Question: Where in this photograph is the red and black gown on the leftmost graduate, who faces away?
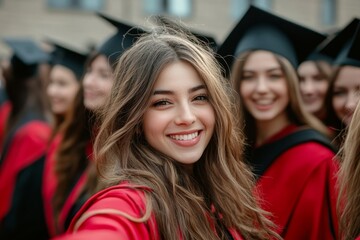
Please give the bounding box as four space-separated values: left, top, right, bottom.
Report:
0 120 51 239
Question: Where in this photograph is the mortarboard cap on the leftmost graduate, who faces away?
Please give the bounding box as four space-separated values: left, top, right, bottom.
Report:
4 38 49 79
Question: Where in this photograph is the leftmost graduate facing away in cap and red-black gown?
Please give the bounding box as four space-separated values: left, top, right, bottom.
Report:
0 39 51 239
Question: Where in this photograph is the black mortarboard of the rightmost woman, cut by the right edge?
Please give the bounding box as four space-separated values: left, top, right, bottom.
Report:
320 18 360 67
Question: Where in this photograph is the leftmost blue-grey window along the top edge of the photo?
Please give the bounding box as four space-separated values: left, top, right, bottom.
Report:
47 0 104 11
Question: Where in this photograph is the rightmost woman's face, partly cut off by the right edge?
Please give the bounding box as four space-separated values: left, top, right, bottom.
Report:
332 66 360 125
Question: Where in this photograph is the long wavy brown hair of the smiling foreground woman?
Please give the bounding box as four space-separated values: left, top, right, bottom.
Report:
94 27 278 240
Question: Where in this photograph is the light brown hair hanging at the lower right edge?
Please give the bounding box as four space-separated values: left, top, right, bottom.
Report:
337 101 360 240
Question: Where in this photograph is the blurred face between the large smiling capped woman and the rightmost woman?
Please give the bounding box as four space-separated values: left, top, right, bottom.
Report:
298 61 329 114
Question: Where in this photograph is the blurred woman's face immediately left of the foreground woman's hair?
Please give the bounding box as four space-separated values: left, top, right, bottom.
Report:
83 55 114 110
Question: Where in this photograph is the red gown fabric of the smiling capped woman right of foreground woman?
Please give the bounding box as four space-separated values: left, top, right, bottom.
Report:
256 126 338 240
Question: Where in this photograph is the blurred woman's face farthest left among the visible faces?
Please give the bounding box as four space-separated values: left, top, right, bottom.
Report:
46 65 80 115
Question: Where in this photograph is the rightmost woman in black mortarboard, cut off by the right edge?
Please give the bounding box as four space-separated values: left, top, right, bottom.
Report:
320 18 360 146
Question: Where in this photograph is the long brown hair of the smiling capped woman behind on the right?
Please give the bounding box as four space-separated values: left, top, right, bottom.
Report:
231 50 330 145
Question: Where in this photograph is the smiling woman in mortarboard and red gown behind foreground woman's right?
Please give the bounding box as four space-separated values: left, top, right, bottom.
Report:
218 6 337 240
